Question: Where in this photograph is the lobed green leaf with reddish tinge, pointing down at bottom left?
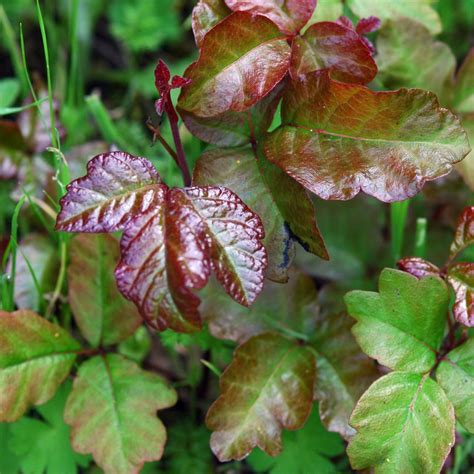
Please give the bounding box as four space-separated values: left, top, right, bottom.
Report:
64 354 176 474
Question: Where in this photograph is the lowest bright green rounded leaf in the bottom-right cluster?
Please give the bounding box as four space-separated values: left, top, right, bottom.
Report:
348 372 455 474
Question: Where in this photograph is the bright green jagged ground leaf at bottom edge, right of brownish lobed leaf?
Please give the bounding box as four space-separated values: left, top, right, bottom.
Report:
246 406 344 474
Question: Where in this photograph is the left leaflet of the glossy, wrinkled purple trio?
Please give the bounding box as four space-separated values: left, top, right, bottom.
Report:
56 151 160 232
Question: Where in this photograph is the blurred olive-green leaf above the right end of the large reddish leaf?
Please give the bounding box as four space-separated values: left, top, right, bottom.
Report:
376 18 456 103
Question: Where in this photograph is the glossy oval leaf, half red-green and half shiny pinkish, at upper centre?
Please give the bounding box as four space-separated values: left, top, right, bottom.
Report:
179 12 290 117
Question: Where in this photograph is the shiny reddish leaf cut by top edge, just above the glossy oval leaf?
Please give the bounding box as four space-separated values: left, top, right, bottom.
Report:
225 0 316 35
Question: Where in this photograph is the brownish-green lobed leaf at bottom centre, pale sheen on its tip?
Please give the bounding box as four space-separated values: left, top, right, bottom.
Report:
206 333 315 461
